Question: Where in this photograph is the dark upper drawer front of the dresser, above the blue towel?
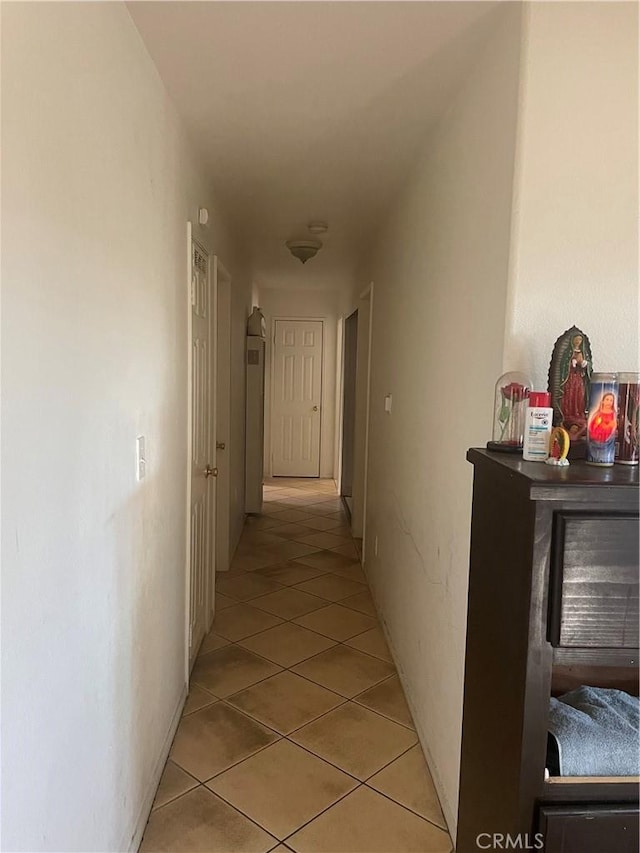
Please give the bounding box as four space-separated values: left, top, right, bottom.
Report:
548 513 639 649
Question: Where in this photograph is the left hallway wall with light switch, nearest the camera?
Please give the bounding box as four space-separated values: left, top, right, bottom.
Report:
1 3 248 851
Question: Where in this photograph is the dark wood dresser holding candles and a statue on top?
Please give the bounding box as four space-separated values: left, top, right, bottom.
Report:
456 450 639 853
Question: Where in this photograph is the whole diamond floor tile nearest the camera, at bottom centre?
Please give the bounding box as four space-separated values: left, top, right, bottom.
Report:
209 741 357 840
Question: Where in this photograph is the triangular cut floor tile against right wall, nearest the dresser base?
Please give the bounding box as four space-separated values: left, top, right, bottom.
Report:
367 744 447 829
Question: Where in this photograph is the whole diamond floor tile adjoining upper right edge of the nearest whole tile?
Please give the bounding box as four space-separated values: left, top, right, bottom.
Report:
288 700 417 781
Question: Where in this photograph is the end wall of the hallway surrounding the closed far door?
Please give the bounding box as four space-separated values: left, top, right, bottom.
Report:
259 288 338 477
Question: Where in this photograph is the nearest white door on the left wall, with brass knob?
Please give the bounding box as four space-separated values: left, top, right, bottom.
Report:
189 233 217 664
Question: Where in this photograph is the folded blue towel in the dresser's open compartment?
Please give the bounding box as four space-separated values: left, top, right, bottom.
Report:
549 687 640 776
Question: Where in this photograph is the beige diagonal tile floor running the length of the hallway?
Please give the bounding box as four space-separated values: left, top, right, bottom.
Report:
141 479 452 853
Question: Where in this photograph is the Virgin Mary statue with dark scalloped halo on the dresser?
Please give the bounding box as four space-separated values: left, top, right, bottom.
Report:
549 326 593 444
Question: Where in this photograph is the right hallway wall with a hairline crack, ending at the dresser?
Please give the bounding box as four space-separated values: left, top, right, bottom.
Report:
363 4 520 831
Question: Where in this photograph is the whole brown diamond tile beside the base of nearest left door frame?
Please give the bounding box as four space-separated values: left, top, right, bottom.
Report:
191 645 280 698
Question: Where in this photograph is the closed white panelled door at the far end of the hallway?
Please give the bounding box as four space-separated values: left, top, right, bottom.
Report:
271 320 323 477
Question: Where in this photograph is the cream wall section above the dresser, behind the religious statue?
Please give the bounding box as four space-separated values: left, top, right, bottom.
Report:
504 3 639 388
